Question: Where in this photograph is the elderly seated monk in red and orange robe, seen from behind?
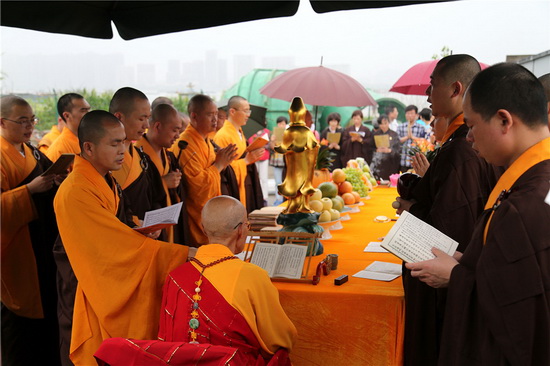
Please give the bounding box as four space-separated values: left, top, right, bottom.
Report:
95 196 297 366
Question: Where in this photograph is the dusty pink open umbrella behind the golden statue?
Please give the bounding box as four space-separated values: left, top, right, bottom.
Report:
260 66 376 107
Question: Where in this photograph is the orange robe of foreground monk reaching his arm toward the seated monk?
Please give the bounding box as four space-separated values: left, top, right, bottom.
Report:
54 156 188 366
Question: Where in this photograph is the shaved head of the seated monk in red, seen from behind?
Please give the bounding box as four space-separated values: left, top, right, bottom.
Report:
202 196 247 239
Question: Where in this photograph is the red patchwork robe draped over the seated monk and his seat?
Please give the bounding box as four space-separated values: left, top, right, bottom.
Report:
94 263 290 366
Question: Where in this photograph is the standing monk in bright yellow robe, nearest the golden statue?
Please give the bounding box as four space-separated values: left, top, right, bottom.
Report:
214 96 265 207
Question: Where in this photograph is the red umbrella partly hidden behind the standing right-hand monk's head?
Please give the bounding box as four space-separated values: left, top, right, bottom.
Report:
390 60 489 95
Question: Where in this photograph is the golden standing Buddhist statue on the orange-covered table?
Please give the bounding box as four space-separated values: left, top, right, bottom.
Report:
275 97 319 214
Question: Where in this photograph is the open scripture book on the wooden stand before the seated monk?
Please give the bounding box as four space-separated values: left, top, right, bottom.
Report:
250 243 307 279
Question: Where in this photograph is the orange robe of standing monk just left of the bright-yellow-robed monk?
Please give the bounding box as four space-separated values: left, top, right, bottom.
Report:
172 125 221 244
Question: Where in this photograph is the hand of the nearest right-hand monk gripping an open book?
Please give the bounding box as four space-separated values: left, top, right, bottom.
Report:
405 248 458 288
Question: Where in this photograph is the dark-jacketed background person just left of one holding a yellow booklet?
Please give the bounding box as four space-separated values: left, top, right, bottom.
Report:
342 109 372 166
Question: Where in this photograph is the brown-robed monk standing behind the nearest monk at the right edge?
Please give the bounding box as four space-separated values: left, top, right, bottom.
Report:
398 55 497 366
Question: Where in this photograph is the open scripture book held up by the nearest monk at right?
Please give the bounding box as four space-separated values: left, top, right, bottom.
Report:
380 211 458 263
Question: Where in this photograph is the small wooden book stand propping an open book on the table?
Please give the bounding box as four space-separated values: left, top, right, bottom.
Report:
244 231 320 283
